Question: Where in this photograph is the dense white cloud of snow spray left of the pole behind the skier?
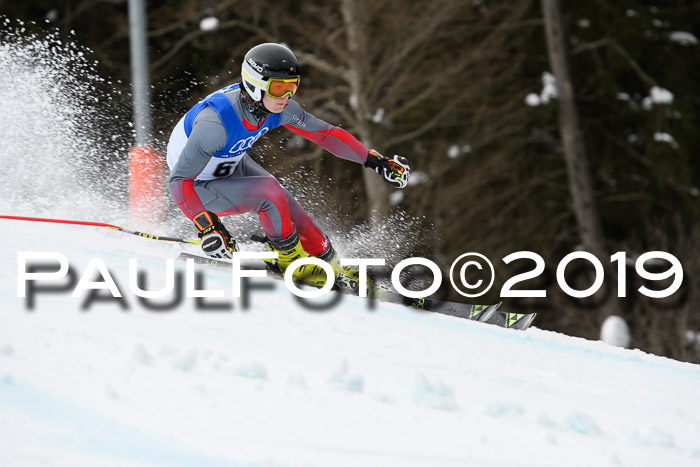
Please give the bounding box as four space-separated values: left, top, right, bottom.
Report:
0 17 131 221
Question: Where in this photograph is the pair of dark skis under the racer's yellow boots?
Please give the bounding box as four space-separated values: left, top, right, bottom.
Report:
177 253 537 330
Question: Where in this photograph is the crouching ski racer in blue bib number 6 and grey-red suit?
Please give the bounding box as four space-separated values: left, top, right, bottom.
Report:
167 43 410 286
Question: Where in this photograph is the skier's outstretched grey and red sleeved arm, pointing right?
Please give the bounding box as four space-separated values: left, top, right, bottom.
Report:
282 99 369 165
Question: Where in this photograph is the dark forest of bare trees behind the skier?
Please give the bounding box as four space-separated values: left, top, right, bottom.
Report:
0 0 700 362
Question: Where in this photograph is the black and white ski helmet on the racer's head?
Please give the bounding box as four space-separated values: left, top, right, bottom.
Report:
241 42 301 102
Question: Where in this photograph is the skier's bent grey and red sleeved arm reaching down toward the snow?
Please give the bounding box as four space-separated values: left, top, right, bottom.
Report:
168 109 226 219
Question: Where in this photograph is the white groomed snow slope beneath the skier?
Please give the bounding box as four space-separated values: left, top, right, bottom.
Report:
0 219 700 467
